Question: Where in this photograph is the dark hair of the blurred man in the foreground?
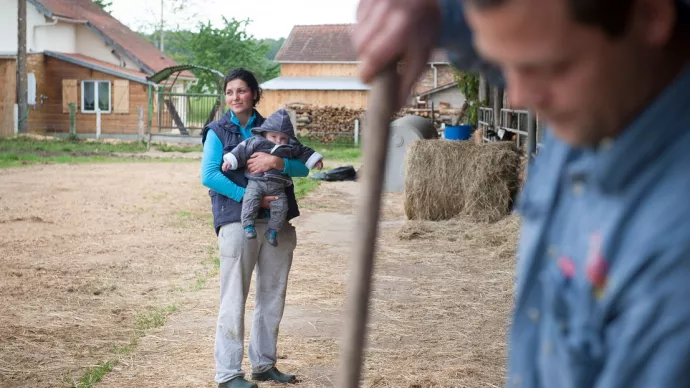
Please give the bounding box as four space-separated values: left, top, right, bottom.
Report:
465 0 676 38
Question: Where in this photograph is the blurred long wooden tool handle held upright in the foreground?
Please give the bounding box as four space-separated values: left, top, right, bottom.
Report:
338 63 399 388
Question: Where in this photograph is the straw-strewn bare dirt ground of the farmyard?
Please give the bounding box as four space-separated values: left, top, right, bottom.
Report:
0 162 517 388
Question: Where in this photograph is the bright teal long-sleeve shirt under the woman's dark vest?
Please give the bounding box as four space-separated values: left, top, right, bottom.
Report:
201 115 309 202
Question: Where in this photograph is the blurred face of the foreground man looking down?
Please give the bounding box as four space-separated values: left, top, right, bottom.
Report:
467 0 664 146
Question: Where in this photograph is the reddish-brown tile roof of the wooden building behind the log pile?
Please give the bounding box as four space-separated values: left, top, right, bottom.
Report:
275 24 448 63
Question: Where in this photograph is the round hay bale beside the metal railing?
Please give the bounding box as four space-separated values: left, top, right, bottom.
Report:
405 140 520 222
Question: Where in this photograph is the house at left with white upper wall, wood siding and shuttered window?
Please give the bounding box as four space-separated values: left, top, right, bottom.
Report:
0 0 195 135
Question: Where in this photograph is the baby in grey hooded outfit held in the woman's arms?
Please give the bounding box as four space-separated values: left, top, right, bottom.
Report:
222 109 323 247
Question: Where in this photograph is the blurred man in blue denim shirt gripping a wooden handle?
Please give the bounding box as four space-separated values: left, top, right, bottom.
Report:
354 0 690 388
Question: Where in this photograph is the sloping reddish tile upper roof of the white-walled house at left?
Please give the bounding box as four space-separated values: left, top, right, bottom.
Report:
31 0 193 77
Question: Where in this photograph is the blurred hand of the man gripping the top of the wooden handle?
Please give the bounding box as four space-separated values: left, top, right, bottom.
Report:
352 0 444 106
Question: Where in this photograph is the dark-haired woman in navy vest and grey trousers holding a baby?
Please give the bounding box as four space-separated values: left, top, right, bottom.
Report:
201 69 309 388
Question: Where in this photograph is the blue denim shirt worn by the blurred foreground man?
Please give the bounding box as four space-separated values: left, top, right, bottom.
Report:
440 0 690 388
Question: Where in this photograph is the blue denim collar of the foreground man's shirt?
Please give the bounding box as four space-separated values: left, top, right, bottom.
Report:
567 66 690 193
